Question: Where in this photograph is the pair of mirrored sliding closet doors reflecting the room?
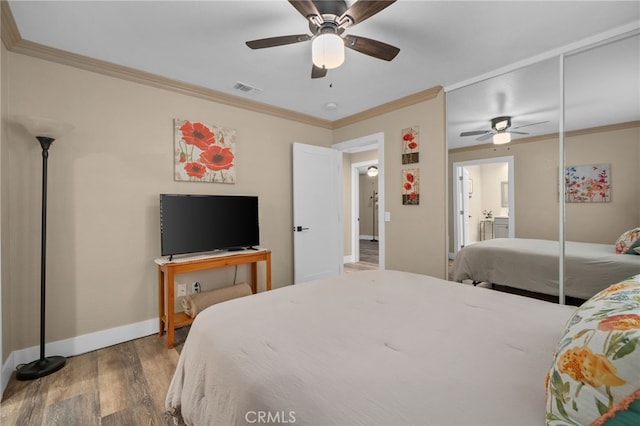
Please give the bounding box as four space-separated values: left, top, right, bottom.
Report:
447 35 640 304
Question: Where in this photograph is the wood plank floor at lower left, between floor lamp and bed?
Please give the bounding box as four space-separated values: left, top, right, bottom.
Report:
0 327 188 426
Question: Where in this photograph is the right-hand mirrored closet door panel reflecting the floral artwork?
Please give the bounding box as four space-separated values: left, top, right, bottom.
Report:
564 35 640 298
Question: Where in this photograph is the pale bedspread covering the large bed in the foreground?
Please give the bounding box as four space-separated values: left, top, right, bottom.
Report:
166 271 574 426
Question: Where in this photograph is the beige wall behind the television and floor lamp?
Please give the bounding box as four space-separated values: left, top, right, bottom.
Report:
0 52 332 359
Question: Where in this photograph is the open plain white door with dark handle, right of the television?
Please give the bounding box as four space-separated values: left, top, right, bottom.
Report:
293 143 343 284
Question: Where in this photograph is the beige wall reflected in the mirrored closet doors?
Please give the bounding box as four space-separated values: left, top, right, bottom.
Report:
448 125 640 247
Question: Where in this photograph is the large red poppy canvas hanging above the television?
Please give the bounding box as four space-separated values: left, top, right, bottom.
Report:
173 118 236 183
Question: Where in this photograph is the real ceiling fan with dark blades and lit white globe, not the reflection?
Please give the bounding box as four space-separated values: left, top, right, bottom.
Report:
246 0 400 78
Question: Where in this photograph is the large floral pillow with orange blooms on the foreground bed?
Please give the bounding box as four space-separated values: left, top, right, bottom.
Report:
546 275 640 426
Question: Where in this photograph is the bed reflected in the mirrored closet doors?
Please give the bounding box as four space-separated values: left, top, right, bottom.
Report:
453 238 640 300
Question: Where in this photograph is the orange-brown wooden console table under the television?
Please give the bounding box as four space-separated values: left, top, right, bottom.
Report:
155 249 271 349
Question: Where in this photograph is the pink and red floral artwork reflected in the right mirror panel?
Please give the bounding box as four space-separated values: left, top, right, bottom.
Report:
564 164 611 203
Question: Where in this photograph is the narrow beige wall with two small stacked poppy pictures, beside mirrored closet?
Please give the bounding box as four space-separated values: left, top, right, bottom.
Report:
334 91 446 278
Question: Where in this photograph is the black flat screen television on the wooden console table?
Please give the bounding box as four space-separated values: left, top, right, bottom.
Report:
160 194 260 256
